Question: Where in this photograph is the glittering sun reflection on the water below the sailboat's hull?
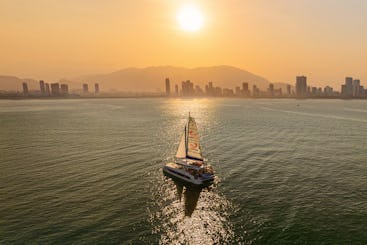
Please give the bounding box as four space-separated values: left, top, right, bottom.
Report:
151 179 234 244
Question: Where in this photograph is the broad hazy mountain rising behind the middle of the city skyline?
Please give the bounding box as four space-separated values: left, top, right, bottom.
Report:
74 66 269 91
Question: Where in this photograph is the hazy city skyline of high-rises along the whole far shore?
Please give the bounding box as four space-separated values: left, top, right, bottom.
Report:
7 75 367 99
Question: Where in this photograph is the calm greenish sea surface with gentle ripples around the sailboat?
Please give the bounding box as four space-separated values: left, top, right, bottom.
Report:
0 99 367 244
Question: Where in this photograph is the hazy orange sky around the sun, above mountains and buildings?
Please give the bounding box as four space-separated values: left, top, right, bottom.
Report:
0 0 367 85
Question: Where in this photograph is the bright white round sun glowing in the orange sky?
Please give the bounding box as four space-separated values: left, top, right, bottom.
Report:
177 5 204 32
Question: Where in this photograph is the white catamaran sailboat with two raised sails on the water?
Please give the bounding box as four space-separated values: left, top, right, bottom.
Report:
163 114 214 187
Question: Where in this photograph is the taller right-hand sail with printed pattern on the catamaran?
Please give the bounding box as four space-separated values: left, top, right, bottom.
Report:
187 117 203 160
